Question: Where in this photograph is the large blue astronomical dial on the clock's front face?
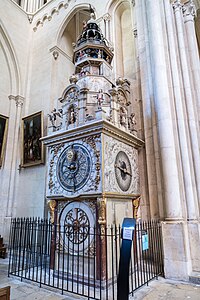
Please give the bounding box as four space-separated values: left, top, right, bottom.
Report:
57 143 91 192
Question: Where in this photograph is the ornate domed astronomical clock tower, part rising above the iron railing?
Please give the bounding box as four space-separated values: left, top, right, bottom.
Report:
43 14 143 240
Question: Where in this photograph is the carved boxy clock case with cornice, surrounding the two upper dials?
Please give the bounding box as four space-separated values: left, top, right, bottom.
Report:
43 120 143 224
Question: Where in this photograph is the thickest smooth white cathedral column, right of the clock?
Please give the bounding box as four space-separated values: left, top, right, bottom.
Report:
146 0 183 220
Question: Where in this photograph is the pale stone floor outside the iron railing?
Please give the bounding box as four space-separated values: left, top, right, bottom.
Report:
0 259 200 300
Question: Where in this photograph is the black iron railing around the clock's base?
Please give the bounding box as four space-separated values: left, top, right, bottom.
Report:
8 218 163 300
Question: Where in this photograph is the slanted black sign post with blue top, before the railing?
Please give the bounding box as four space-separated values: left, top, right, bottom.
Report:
117 218 136 300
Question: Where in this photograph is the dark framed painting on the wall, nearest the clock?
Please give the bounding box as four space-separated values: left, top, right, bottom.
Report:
22 111 44 167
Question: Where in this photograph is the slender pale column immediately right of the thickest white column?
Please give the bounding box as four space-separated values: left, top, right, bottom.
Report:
164 1 198 220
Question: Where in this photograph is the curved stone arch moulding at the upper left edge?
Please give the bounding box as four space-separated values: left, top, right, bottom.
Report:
0 21 21 95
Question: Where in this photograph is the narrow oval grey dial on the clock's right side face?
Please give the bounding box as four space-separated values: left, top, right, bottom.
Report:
115 151 132 192
